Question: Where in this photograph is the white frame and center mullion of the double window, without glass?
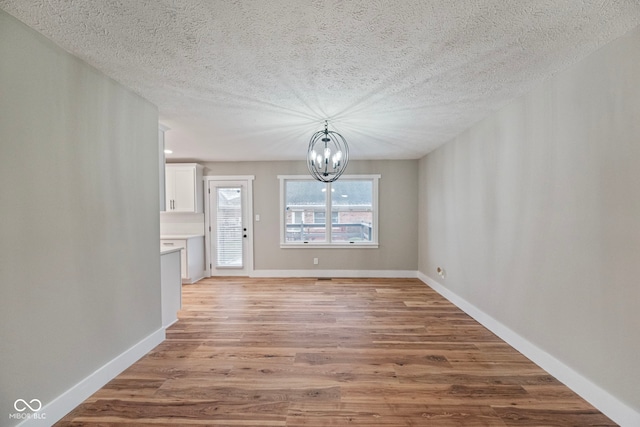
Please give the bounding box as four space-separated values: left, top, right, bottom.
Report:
278 175 381 249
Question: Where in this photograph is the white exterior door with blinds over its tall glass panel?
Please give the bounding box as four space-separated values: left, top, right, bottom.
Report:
207 179 252 276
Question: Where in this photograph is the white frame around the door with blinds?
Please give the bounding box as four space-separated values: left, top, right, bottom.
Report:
204 175 255 277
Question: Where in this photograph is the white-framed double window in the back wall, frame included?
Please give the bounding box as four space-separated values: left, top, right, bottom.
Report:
278 175 380 247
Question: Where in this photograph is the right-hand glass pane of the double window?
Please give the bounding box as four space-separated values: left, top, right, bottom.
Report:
331 180 373 242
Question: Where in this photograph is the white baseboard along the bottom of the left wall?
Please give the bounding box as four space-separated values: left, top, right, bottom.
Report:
18 328 165 427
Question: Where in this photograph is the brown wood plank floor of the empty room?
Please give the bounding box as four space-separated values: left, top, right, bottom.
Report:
57 278 615 427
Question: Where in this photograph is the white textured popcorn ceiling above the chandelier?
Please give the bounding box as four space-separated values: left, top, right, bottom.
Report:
0 0 640 161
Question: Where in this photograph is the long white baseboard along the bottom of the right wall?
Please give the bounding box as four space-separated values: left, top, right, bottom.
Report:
418 272 640 427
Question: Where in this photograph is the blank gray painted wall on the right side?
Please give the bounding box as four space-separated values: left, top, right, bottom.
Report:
419 29 640 411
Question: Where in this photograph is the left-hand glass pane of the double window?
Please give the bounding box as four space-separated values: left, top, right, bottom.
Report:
285 181 327 243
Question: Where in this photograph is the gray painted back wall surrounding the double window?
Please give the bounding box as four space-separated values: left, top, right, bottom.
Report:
204 160 418 271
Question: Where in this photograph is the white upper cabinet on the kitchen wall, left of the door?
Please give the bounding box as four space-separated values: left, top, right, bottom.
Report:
165 163 204 213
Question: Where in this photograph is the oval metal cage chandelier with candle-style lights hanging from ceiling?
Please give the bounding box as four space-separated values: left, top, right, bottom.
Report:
307 120 349 182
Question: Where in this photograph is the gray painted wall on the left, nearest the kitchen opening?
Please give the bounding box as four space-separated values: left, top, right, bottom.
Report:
0 11 161 425
